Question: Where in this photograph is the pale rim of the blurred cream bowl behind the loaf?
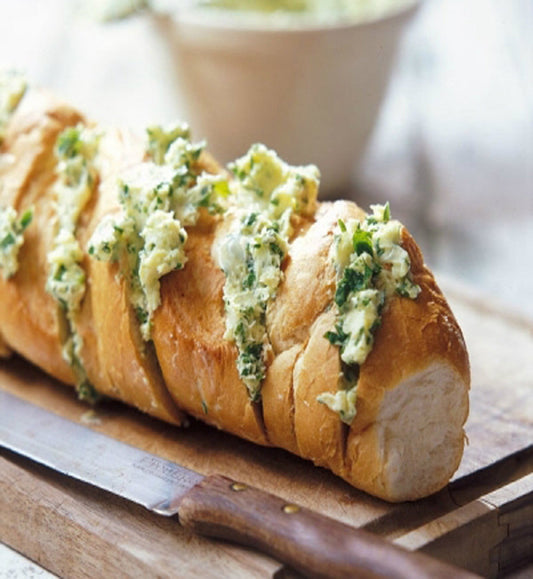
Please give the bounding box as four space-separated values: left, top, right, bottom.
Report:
171 0 424 34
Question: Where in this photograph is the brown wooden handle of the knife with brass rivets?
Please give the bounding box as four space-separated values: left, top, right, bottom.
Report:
179 476 476 579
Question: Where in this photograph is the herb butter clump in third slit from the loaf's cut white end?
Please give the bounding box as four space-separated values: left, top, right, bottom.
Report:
89 124 228 341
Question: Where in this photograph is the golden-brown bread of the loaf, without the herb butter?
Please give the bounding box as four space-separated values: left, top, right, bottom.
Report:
0 88 470 501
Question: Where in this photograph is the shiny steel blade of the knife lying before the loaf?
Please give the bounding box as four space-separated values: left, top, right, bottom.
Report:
0 391 204 516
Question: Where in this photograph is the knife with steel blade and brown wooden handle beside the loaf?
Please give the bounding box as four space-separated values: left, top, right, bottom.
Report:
0 390 475 579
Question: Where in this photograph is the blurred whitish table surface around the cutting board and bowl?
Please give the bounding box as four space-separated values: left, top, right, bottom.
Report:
0 0 533 578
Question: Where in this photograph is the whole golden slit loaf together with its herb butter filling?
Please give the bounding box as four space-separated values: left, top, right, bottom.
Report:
0 78 470 501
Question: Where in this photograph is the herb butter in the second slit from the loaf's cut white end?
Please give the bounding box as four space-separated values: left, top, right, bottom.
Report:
215 145 319 401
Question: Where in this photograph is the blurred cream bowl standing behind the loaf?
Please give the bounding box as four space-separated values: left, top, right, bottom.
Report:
156 2 418 197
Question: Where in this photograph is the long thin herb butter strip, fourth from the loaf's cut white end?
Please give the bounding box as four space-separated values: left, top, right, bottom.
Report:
46 125 100 401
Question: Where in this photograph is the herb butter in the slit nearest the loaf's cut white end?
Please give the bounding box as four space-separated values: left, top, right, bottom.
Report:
318 204 420 424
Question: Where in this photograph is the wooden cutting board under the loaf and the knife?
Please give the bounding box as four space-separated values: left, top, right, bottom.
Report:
0 280 533 577
